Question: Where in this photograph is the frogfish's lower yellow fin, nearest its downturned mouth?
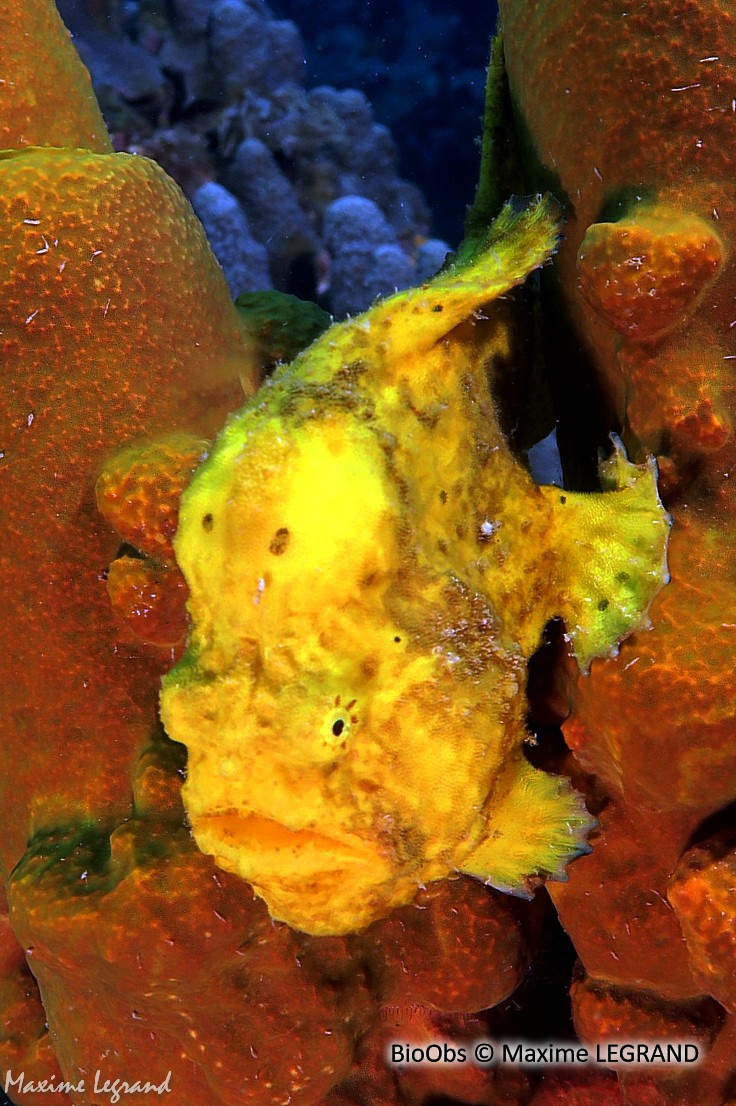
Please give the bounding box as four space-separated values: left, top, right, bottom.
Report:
460 758 595 898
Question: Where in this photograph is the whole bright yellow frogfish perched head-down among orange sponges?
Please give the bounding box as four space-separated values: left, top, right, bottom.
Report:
162 202 668 935
